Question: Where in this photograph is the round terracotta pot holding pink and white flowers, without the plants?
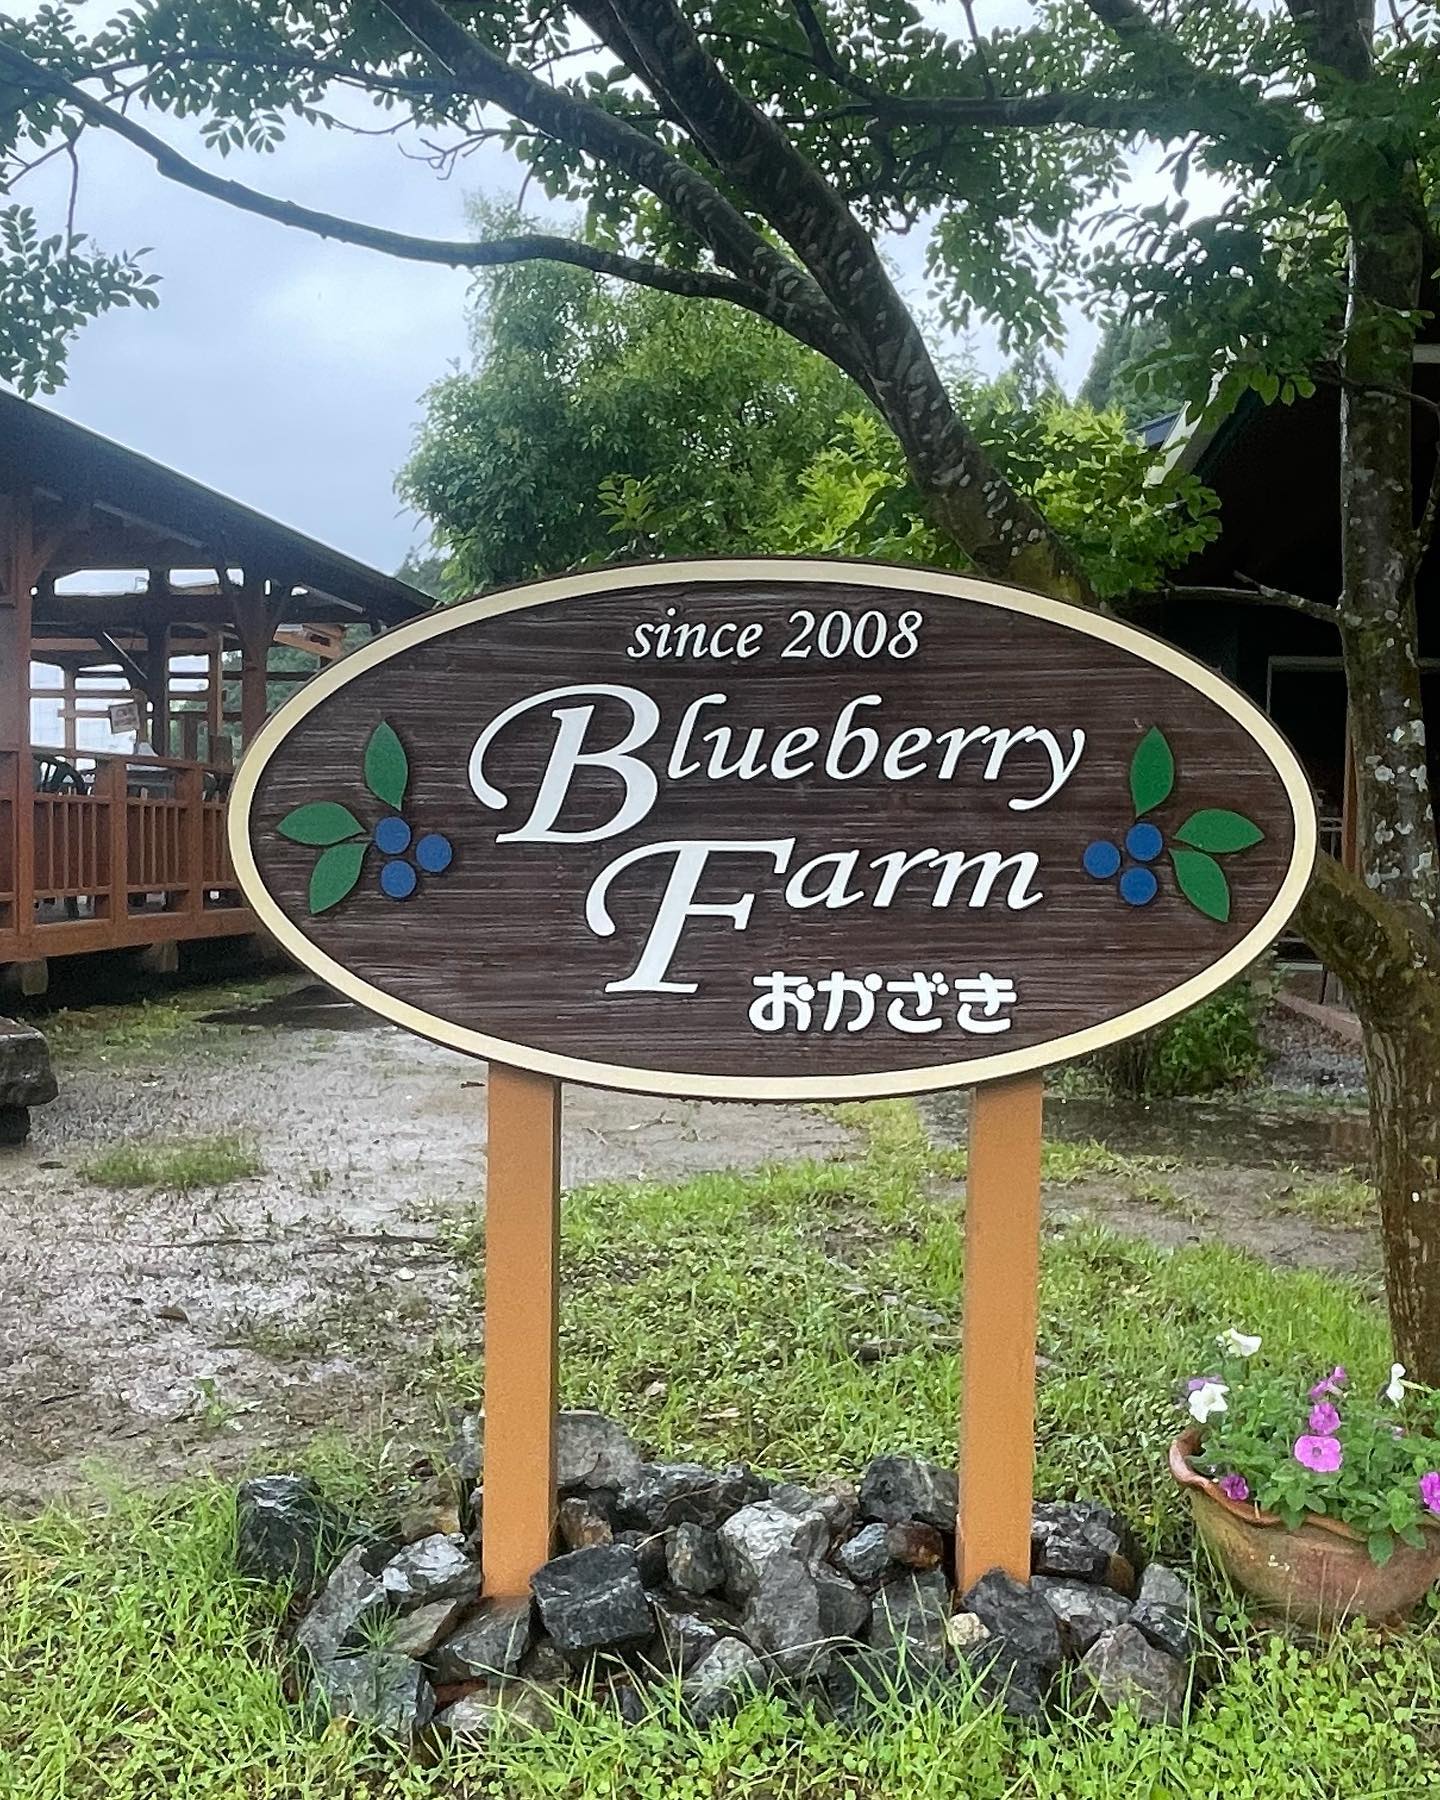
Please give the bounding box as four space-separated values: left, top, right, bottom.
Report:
1170 1429 1440 1627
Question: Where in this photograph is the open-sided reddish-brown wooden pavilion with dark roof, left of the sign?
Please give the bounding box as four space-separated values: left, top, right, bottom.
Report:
0 394 430 992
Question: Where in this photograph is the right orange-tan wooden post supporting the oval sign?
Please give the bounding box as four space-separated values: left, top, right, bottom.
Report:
956 1075 1044 1593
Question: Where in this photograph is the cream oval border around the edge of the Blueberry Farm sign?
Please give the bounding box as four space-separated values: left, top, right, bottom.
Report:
229 558 1316 1100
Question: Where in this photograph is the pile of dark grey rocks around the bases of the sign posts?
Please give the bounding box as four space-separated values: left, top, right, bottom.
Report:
238 1413 1199 1737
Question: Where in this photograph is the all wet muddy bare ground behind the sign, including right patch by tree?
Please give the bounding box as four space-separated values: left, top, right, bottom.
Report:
0 977 1375 1505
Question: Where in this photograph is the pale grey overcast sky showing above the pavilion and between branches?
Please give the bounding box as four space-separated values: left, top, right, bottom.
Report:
0 0 1093 569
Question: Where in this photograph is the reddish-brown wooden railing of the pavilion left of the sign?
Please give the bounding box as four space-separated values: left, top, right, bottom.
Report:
0 751 256 963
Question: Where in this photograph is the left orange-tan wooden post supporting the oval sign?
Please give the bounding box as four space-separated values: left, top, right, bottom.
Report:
482 1062 560 1598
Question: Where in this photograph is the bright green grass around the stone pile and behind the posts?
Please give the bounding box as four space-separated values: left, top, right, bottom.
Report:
0 1103 1440 1800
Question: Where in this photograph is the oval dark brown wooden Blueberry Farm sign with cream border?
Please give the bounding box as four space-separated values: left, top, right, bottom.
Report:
230 560 1316 1100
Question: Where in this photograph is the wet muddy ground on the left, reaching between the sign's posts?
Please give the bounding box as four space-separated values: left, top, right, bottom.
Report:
0 988 848 1503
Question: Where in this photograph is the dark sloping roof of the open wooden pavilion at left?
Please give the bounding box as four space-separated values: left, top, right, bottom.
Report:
0 392 432 625
